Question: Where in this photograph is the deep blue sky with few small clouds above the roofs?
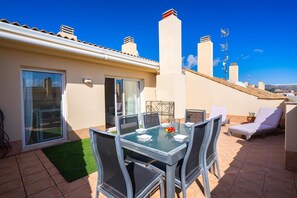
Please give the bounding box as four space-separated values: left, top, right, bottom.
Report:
0 0 297 84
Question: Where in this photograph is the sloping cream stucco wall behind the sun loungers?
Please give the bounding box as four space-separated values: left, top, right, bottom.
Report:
186 71 285 116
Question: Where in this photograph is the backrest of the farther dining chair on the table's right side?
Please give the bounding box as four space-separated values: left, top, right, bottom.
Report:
206 115 222 159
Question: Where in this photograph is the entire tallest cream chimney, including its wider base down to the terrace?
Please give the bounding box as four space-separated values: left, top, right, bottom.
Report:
156 9 186 119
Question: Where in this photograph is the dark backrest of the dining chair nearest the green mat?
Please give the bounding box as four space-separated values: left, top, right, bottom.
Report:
90 128 133 197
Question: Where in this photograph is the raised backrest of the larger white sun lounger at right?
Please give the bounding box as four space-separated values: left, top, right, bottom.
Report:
254 108 283 127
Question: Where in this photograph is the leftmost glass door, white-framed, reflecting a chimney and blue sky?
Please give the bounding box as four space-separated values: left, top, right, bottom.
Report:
22 70 64 146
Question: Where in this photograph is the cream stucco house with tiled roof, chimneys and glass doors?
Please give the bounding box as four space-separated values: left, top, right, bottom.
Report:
0 9 286 153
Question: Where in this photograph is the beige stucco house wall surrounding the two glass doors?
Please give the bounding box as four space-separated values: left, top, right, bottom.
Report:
0 47 156 141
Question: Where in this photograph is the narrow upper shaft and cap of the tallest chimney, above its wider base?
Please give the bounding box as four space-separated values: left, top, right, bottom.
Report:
159 9 182 74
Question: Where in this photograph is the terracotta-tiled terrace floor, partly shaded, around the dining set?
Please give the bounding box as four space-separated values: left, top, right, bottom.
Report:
0 128 297 198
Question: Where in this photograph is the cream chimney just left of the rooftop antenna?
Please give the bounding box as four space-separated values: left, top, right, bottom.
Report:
197 36 213 77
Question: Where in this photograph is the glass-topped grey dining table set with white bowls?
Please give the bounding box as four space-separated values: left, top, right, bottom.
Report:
121 123 191 198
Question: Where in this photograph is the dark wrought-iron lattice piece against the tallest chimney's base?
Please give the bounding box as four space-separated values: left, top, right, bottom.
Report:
146 101 174 122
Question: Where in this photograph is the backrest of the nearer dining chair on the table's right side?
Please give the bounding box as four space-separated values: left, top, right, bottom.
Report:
181 119 213 184
